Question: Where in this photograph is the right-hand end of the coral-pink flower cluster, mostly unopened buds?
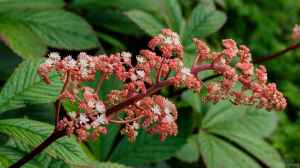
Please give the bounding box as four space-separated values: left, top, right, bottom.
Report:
194 39 287 110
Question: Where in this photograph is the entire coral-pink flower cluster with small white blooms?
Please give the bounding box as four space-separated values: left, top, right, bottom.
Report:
38 29 286 141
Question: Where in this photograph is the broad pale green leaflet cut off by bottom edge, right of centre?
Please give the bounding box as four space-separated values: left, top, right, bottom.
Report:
198 132 260 168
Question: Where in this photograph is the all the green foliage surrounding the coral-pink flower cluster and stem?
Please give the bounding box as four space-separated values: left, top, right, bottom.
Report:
0 0 300 168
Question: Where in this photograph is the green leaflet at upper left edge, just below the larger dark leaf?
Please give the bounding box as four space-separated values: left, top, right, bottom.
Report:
0 21 47 59
